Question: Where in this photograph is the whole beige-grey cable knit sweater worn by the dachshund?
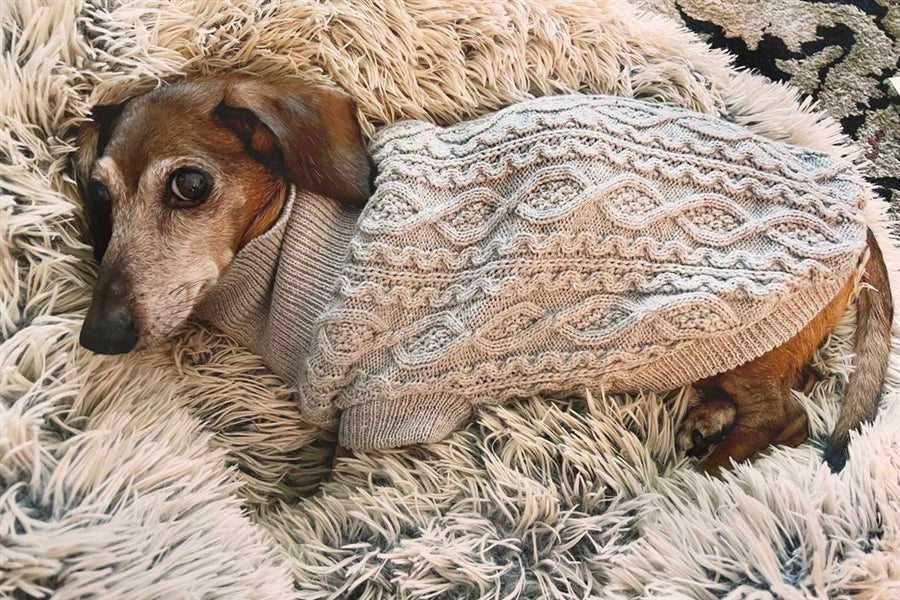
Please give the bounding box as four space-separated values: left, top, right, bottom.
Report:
193 96 867 449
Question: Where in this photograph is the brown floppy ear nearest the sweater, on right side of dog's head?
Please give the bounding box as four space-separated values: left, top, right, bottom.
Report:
216 79 372 207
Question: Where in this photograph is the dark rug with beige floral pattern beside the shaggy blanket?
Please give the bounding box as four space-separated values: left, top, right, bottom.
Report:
646 0 900 218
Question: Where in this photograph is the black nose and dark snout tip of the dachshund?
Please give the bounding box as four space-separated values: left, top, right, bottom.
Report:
78 270 140 354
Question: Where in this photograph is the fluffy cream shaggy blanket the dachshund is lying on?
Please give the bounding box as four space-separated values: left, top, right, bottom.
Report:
0 0 900 599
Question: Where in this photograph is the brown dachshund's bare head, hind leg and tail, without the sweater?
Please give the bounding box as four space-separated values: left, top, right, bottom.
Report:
75 78 893 474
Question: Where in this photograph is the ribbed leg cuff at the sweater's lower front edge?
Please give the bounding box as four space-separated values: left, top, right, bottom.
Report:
338 396 472 450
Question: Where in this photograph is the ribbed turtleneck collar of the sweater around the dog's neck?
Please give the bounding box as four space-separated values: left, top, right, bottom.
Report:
196 186 360 383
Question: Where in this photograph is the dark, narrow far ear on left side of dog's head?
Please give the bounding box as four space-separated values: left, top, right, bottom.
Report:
75 104 123 262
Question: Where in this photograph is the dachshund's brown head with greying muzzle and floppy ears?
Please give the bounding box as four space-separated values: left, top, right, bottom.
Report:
76 79 372 354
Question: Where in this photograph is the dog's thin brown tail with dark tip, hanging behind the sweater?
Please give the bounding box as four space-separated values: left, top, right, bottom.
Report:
825 230 894 473
